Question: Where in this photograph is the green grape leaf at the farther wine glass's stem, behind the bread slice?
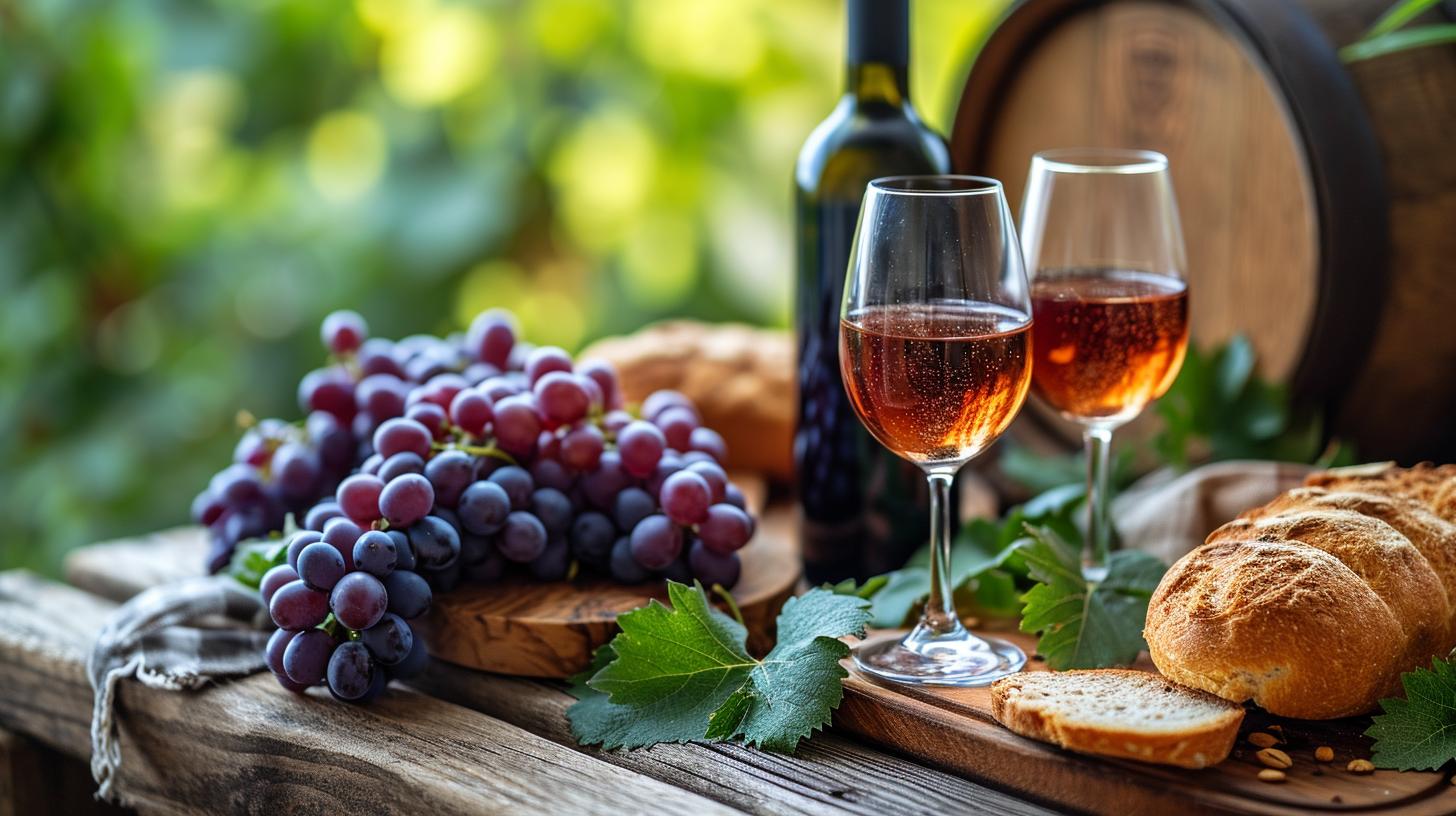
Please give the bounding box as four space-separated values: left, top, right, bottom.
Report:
1019 525 1166 672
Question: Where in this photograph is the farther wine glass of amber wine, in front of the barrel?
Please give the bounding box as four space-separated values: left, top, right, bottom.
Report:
1021 149 1188 581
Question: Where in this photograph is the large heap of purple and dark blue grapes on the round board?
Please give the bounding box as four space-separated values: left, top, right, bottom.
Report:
206 310 756 702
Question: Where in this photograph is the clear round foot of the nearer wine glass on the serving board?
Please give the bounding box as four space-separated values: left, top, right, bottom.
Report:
855 627 1026 686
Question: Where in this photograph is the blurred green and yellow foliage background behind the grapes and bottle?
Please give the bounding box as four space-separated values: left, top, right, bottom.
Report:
0 0 1005 574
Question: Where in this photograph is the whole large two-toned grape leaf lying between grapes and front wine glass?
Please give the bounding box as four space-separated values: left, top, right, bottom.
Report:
566 581 869 752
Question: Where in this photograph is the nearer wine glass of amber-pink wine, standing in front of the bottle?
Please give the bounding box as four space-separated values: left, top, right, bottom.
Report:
839 176 1031 685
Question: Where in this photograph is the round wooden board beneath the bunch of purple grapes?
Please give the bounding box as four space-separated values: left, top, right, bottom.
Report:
415 519 799 678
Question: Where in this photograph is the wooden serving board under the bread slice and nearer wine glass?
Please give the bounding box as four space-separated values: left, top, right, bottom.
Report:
834 631 1456 816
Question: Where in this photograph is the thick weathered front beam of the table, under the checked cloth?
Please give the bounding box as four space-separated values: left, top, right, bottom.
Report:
0 573 737 816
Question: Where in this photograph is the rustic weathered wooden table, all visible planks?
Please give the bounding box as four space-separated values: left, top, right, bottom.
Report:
0 532 1053 816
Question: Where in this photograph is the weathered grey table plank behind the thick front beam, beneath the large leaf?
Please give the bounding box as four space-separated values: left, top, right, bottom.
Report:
67 532 1051 816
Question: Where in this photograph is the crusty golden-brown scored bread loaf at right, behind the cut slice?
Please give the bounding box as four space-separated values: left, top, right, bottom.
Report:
1144 465 1456 718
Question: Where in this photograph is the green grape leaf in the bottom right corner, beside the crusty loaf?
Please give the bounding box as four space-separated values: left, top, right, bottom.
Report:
1366 659 1456 771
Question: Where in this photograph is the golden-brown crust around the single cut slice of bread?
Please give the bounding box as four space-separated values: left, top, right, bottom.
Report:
992 669 1243 768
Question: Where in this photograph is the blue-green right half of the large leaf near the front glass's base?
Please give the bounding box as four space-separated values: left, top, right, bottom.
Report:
706 592 869 753
